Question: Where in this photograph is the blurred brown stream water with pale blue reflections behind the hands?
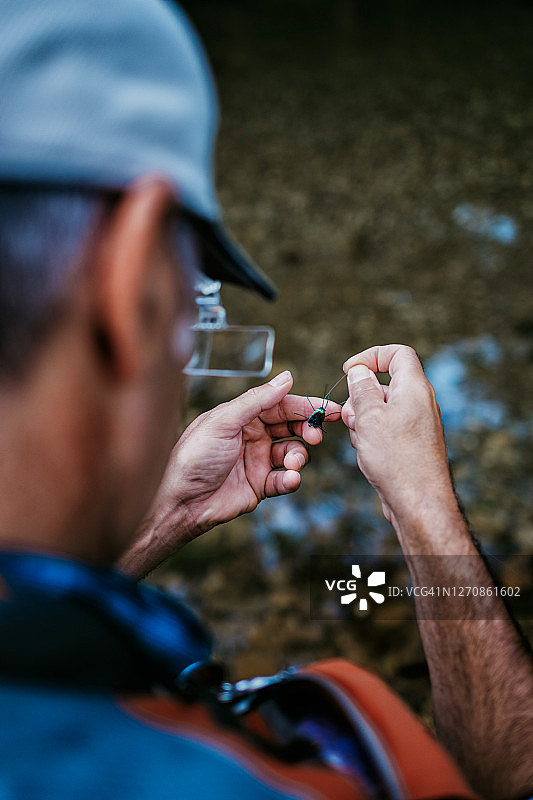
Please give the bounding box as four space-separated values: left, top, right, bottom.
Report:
156 0 533 720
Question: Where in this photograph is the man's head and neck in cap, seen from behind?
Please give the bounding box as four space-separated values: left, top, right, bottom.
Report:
0 0 273 560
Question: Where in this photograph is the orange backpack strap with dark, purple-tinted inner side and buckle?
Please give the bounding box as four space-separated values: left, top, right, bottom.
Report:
127 659 477 800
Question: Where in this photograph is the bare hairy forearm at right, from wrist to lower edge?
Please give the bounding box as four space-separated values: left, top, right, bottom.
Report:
393 498 533 800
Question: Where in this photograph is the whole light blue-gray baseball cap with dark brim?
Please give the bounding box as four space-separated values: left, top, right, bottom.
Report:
0 0 275 299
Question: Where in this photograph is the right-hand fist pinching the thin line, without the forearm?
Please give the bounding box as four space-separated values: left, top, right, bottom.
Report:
342 344 458 529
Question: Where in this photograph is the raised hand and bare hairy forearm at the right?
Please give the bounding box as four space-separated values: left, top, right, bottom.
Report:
342 345 533 800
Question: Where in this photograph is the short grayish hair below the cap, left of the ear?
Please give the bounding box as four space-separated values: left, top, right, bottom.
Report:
0 184 112 380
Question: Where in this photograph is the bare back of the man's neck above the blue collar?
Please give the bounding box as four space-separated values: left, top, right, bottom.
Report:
0 347 113 564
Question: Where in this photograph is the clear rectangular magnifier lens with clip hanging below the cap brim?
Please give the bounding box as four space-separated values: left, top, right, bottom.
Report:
183 277 275 378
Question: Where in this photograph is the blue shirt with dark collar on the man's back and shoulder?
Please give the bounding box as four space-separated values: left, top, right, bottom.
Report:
0 553 366 800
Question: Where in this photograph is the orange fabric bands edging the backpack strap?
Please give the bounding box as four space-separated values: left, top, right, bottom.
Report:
120 659 479 800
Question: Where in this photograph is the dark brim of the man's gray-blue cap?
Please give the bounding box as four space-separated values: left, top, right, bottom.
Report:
188 214 277 300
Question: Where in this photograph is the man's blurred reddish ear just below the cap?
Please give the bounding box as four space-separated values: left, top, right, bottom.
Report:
89 177 175 379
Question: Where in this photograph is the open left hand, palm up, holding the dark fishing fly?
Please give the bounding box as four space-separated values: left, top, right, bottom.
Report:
120 372 341 577
